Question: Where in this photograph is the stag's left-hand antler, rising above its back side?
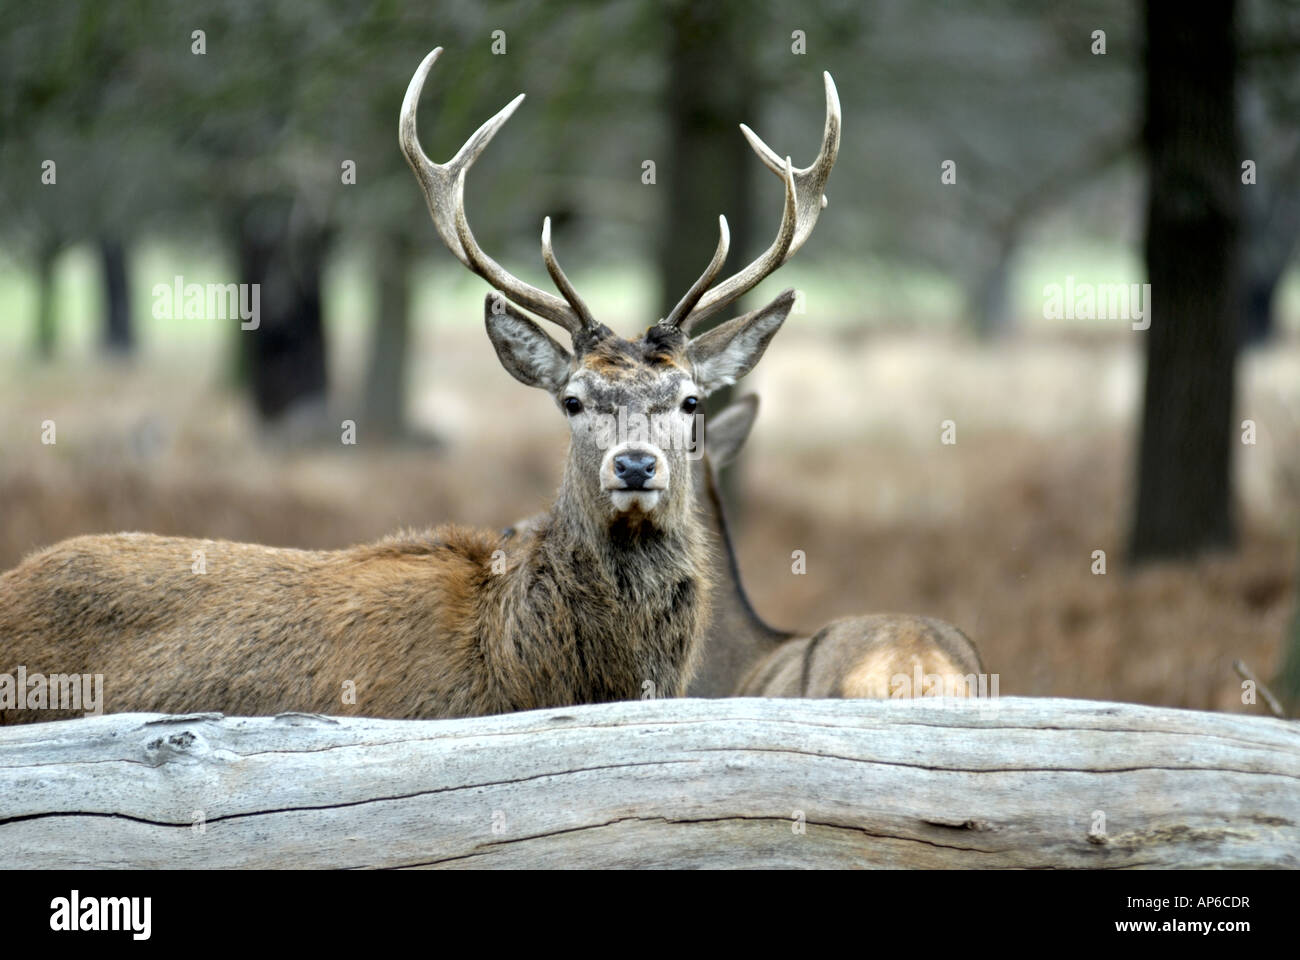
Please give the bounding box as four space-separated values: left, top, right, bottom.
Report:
398 47 595 334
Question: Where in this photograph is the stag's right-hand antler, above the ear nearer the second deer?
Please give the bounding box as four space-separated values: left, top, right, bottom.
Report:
660 73 840 332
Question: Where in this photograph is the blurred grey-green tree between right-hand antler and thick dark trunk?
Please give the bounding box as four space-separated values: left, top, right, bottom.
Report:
800 0 1138 337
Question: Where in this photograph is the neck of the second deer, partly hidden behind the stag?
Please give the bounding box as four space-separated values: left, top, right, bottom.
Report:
688 459 794 697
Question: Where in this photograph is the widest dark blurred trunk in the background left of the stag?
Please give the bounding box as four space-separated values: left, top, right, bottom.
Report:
230 198 326 421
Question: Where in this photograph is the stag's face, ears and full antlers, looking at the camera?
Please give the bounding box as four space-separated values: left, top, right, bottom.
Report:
398 47 840 526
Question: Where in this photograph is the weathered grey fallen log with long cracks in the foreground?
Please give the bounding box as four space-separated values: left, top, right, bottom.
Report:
0 699 1300 868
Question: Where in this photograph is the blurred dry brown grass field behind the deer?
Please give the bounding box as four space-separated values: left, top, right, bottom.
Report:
0 324 1300 712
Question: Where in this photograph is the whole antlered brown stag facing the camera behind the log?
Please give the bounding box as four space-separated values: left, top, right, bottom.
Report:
0 48 840 722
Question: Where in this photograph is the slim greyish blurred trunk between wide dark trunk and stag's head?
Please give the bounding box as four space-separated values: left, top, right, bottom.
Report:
365 233 411 438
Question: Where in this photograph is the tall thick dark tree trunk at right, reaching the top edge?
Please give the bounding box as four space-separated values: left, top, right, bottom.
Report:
1130 0 1242 561
